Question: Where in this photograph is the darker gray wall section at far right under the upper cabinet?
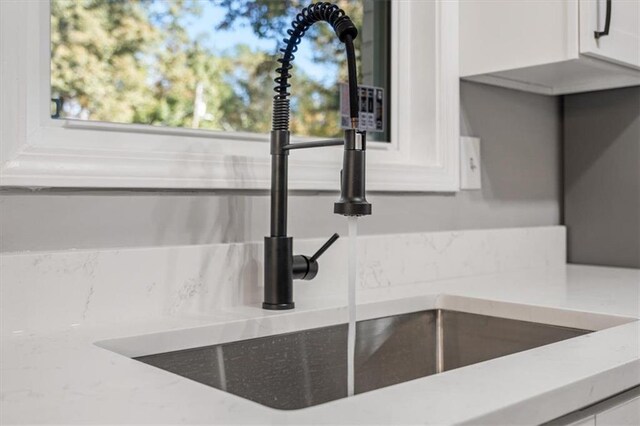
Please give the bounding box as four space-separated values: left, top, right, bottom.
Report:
564 87 640 268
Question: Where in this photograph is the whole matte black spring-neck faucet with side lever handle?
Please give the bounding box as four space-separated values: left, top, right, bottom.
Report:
262 2 371 310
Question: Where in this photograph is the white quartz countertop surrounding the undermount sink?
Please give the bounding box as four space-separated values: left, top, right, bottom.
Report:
0 265 640 424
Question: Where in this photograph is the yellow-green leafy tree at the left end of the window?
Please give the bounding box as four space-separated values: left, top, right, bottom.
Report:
51 0 160 122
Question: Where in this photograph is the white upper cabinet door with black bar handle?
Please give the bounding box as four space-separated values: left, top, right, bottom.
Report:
580 0 640 69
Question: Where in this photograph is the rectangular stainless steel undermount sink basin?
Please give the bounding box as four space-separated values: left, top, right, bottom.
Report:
135 310 590 410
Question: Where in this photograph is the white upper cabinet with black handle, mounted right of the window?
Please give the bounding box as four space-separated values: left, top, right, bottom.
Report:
460 0 640 95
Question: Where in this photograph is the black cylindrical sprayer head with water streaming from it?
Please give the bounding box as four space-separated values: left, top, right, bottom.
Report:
333 129 371 216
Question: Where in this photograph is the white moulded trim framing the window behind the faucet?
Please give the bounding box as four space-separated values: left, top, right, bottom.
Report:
0 0 459 191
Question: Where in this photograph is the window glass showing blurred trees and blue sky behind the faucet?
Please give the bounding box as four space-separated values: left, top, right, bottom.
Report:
51 0 390 140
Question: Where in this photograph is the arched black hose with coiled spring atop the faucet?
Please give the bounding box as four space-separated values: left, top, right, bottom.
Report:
272 2 358 130
